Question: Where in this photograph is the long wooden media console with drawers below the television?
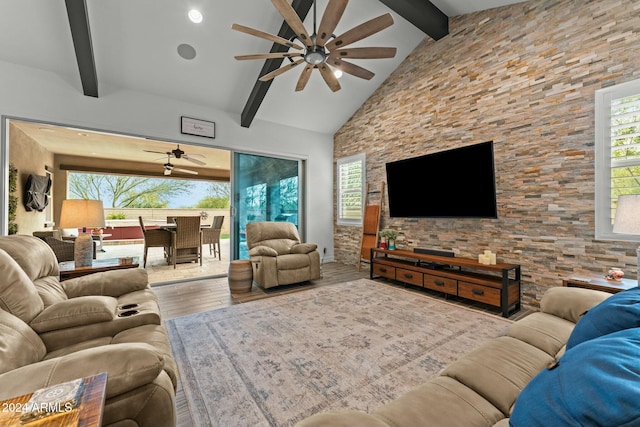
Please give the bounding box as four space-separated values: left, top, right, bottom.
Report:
370 248 520 317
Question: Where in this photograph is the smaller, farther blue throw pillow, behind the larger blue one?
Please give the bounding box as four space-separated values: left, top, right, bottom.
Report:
567 287 640 350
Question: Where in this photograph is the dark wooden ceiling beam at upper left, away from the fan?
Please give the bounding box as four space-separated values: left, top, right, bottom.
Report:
65 0 98 98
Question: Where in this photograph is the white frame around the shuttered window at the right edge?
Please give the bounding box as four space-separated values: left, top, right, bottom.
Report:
595 80 640 242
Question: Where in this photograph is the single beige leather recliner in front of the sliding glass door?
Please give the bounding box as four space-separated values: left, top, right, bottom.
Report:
246 222 321 288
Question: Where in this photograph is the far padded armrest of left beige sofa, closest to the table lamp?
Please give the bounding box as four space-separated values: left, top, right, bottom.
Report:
61 268 149 298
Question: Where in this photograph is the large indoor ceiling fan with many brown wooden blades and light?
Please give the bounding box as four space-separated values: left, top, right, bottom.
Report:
231 0 396 92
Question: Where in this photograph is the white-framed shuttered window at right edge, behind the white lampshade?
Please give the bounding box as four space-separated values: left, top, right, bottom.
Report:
595 80 640 241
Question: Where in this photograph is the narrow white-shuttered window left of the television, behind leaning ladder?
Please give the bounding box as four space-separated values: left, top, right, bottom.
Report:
336 154 366 225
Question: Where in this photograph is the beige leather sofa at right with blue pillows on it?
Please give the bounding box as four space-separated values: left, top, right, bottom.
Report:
296 287 640 427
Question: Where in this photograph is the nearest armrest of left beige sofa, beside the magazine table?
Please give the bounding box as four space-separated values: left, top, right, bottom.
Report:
0 343 164 400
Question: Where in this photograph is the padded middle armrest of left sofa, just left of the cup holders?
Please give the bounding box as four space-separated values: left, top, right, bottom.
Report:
29 295 118 334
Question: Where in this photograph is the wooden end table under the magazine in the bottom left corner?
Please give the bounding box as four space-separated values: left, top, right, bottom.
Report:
0 372 107 427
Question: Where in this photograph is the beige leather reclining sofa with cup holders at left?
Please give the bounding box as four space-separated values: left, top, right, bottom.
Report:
0 235 177 426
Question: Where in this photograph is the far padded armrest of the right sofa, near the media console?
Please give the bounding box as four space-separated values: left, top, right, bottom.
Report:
540 286 612 323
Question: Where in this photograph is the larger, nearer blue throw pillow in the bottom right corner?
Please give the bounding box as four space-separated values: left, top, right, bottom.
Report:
509 328 640 427
